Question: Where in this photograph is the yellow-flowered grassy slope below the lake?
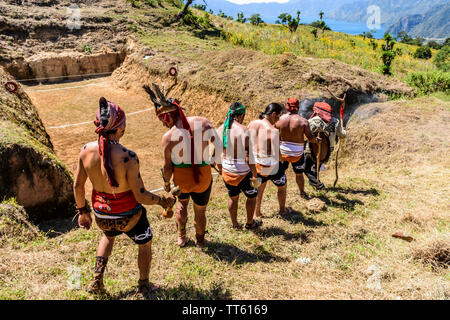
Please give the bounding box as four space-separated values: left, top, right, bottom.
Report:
220 21 436 80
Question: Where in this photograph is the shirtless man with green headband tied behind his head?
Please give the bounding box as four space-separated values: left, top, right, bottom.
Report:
218 102 262 229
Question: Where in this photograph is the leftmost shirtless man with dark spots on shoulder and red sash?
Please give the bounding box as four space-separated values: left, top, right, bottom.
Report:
74 97 175 295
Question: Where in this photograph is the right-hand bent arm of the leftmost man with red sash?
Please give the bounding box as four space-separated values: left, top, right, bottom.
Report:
125 156 174 208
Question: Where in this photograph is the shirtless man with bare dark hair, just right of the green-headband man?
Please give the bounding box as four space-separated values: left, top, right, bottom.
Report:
248 103 287 219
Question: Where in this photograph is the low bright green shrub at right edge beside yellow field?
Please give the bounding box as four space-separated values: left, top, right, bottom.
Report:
406 71 450 94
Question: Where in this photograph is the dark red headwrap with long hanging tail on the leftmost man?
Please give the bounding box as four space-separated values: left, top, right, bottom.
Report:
94 97 126 187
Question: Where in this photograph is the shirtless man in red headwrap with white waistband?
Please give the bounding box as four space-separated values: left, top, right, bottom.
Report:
275 98 317 198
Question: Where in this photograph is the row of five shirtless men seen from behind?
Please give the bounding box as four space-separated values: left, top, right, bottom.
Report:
74 92 334 295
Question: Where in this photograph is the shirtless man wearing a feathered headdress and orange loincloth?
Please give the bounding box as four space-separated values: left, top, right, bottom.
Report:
144 84 220 248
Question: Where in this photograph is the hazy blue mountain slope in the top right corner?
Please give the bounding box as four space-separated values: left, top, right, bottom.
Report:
386 3 450 39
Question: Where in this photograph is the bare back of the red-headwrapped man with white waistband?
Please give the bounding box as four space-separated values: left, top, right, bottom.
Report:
275 114 312 143
